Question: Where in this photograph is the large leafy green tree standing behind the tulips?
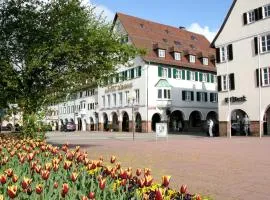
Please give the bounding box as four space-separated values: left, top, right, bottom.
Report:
0 0 138 115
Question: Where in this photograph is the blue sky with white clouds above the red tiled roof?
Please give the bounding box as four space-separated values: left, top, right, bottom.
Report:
83 0 233 42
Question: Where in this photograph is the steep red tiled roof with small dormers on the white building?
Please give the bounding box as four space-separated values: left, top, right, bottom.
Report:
114 13 216 72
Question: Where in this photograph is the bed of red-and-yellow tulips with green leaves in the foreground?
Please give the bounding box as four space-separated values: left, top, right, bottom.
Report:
0 135 209 200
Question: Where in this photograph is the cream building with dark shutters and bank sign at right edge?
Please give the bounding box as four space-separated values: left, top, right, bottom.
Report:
212 0 270 136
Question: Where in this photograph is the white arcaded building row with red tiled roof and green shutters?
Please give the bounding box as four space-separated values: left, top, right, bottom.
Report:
48 13 217 132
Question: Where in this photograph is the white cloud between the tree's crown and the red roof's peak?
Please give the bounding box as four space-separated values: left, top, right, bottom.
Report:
82 0 115 22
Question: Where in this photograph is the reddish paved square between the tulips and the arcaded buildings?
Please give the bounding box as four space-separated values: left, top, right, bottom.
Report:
47 132 270 200
